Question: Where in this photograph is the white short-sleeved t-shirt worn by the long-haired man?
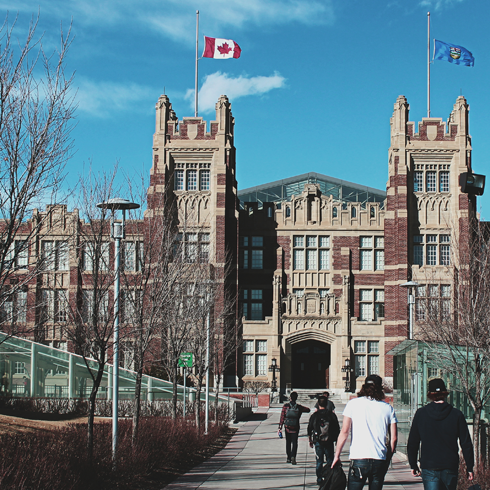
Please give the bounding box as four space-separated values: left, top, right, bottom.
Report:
343 396 397 459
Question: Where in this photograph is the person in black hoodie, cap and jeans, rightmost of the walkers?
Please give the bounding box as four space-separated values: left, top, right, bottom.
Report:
407 378 474 490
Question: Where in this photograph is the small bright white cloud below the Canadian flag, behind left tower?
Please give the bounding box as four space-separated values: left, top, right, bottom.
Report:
185 71 286 113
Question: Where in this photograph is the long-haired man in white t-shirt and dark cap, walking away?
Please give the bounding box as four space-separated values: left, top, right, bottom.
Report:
332 374 397 490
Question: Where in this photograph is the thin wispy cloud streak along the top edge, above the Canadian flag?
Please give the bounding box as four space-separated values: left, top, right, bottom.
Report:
0 0 335 42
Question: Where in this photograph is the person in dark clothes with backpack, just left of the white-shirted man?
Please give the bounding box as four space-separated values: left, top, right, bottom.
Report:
308 396 340 485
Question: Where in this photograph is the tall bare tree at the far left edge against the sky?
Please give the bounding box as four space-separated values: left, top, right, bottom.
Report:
0 14 75 333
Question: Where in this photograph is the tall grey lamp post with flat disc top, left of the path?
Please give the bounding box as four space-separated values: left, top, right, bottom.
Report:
97 197 140 464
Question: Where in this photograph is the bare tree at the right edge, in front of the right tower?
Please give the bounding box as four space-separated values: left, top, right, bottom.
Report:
417 220 490 468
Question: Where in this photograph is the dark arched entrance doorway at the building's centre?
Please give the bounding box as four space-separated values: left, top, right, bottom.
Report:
291 340 330 388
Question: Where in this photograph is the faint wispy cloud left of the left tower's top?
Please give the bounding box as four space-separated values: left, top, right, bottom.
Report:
75 77 155 117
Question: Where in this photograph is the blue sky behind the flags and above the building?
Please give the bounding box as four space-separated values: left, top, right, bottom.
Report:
5 0 490 220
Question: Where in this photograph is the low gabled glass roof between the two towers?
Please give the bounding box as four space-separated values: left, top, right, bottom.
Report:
238 172 386 209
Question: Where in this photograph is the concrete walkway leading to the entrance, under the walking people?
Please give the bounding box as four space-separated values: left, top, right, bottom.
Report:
165 407 423 490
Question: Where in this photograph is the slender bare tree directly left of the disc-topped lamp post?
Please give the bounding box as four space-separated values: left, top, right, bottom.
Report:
66 170 116 458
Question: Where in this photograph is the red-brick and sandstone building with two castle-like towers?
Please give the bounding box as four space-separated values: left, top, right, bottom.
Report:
0 95 482 392
